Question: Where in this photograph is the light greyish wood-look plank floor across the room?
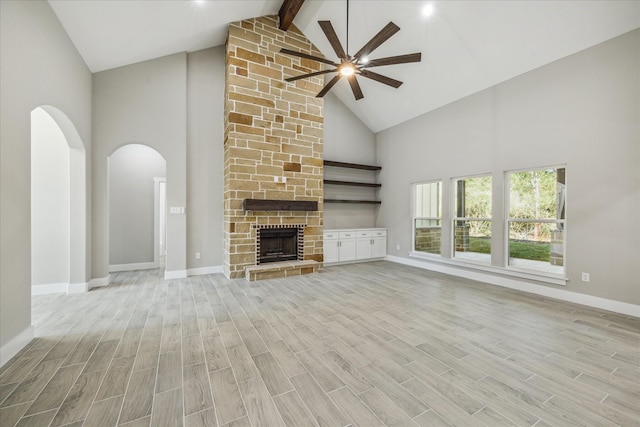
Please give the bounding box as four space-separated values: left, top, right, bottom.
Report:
0 261 640 427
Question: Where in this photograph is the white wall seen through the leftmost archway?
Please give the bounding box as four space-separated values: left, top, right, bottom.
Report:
31 108 71 285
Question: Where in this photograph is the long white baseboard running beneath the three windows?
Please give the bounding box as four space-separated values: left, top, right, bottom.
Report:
385 255 640 317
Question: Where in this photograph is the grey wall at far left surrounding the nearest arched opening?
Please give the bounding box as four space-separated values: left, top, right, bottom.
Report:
0 0 91 358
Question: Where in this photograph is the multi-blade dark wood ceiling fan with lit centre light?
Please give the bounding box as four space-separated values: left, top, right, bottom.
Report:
280 0 422 101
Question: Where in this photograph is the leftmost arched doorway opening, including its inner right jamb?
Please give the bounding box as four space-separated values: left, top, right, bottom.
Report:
31 105 89 294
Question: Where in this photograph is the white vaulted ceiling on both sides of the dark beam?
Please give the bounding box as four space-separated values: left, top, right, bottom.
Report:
49 0 640 132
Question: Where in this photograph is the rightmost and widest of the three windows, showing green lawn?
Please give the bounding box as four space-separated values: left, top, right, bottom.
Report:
507 167 566 274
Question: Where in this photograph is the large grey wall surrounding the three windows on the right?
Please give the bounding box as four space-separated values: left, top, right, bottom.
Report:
377 30 640 305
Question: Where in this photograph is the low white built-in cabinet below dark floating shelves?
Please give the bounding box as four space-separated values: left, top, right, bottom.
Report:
323 228 387 264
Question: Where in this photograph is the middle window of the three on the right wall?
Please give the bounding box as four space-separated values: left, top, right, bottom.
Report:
453 176 491 263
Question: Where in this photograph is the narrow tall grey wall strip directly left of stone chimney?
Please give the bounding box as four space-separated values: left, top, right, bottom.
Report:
187 46 225 269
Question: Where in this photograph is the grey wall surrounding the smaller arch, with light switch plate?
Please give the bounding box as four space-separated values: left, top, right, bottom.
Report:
92 53 187 278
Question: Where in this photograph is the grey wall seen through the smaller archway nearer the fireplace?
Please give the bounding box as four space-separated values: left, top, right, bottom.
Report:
109 144 167 265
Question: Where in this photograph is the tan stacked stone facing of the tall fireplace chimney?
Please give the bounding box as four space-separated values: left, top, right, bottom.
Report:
223 16 324 278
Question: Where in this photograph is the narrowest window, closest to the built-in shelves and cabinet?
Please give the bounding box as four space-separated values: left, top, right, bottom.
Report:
413 181 442 255
